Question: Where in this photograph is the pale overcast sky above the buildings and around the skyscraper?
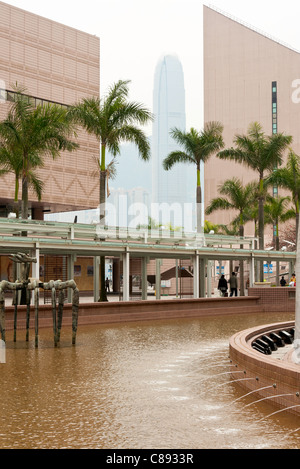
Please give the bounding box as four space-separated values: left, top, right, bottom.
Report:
5 0 300 133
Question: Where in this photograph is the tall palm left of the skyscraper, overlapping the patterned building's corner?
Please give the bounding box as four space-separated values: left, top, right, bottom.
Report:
72 80 152 301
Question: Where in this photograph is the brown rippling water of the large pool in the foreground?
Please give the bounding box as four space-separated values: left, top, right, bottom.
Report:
0 314 300 449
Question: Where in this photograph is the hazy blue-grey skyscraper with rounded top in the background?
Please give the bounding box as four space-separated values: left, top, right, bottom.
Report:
152 55 194 226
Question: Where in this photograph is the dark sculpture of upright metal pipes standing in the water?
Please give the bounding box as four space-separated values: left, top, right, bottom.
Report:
0 253 79 348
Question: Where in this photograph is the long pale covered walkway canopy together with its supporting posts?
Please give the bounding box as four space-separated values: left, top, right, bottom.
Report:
0 219 296 301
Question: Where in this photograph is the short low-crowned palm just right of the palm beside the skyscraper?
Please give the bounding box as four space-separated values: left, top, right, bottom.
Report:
206 178 257 296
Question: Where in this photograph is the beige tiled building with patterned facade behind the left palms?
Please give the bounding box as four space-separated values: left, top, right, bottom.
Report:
0 2 100 219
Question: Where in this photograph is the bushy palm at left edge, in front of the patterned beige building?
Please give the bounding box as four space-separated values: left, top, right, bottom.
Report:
0 85 78 219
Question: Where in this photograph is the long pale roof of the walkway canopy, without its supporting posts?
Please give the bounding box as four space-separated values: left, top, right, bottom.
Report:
0 218 296 262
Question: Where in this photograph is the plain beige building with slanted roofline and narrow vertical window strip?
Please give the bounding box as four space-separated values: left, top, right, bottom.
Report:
204 7 300 238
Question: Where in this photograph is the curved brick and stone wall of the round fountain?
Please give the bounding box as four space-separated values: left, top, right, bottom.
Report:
229 322 300 416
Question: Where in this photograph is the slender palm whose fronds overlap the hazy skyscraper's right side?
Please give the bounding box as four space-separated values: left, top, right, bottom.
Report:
163 122 224 232
